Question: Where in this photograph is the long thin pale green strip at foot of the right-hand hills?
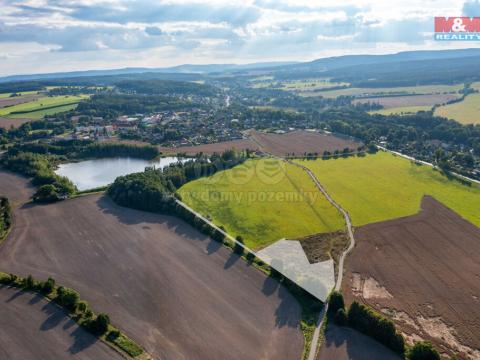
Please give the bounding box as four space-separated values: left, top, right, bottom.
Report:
302 84 463 98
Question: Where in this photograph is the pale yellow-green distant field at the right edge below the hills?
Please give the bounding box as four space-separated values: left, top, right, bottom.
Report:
435 93 480 124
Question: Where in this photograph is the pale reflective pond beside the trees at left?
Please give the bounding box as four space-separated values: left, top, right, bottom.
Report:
55 157 185 191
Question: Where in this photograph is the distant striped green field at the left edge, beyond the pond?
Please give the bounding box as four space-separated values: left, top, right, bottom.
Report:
0 95 88 119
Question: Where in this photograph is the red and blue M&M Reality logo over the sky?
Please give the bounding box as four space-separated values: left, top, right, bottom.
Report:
434 17 480 41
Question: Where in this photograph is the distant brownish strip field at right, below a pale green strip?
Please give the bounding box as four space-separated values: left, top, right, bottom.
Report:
353 94 459 109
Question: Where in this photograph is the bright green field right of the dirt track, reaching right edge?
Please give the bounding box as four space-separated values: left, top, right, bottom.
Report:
298 152 480 226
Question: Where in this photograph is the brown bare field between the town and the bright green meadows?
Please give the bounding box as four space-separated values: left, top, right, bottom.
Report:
250 131 361 156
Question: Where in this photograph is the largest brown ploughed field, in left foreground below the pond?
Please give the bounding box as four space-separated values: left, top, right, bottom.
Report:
0 195 304 360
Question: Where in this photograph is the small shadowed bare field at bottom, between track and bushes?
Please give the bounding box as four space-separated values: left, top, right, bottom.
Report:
317 324 400 360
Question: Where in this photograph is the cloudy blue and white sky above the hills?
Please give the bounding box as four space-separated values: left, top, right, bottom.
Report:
0 0 480 76
